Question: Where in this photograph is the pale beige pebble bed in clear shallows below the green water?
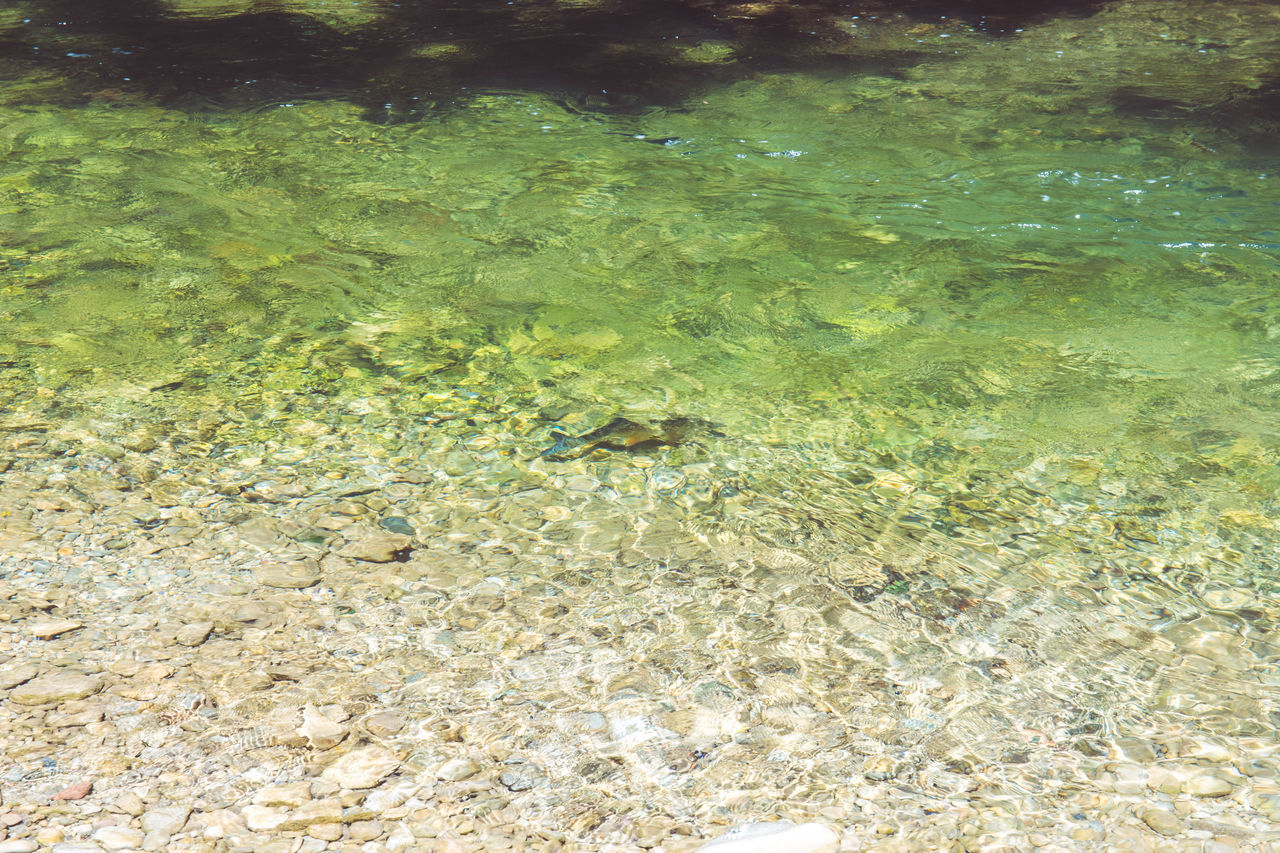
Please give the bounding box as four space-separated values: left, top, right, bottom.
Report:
0 368 1280 853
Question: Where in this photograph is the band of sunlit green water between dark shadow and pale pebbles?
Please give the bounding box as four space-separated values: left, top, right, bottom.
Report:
0 4 1280 506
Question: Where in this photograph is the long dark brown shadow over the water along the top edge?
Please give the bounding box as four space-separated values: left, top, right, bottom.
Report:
0 0 1105 122
